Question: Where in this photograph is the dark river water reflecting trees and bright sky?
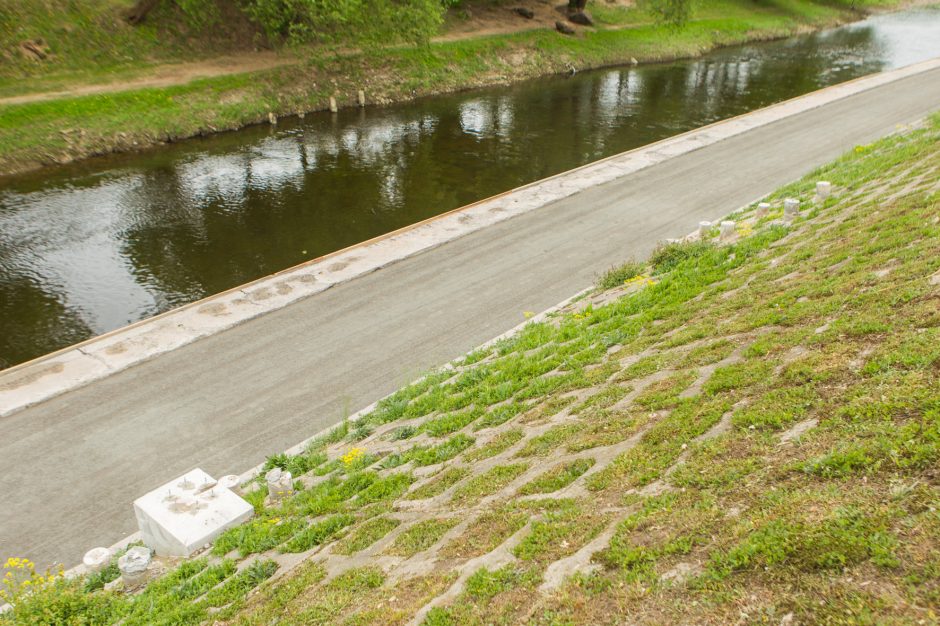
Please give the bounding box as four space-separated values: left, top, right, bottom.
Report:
0 9 940 367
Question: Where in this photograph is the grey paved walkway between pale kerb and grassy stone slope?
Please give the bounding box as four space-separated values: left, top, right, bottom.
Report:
0 62 940 565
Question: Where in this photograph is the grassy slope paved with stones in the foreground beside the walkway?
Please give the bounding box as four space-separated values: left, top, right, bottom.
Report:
0 116 940 625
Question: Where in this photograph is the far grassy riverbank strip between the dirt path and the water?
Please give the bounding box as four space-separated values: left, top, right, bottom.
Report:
0 0 912 174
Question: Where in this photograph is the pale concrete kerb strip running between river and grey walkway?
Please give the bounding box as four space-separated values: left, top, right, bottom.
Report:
0 58 940 417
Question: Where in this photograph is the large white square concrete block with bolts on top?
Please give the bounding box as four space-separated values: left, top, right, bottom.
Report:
134 468 254 556
